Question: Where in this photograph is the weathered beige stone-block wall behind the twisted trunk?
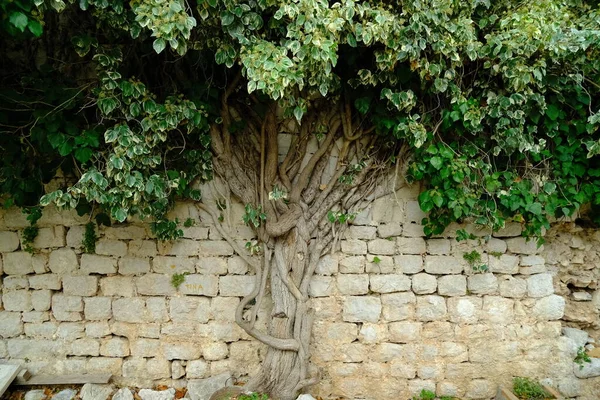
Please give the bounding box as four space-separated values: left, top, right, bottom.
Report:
0 188 600 400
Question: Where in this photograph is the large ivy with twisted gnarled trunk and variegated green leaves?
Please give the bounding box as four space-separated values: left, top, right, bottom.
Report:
0 0 600 399
